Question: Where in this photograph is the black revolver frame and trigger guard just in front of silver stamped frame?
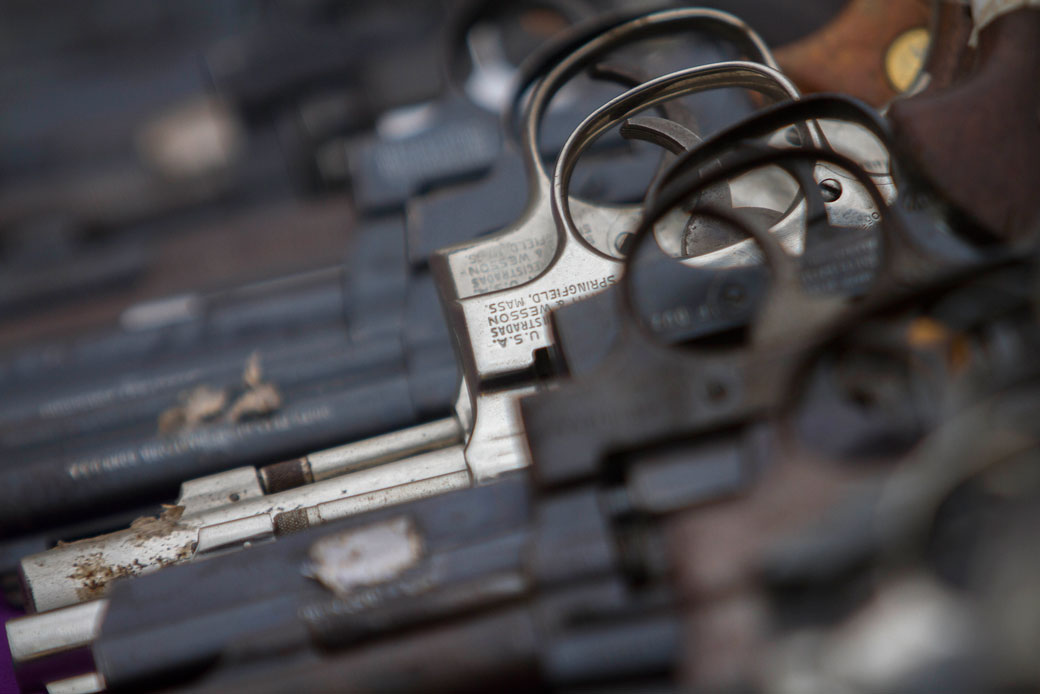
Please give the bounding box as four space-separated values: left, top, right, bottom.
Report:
522 92 990 483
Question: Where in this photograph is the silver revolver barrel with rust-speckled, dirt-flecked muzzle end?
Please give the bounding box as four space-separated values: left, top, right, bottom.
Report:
21 445 470 612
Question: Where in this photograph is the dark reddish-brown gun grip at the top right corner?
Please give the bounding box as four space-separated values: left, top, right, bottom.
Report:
888 9 1040 240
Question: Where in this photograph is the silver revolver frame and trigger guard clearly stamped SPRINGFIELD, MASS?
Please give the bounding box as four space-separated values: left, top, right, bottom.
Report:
448 62 891 479
